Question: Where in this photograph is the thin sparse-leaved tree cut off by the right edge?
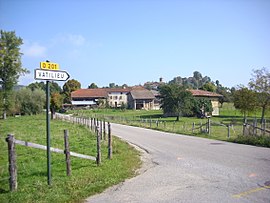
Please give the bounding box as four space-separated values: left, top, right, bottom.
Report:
249 68 270 122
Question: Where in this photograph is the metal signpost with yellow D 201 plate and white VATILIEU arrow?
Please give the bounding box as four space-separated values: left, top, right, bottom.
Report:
35 61 70 185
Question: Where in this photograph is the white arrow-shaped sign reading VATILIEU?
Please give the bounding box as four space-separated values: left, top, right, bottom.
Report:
35 69 70 81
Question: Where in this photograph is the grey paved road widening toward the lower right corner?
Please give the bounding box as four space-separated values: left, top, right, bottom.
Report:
87 124 270 203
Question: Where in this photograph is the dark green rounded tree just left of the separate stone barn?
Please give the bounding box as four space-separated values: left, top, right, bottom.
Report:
160 84 193 121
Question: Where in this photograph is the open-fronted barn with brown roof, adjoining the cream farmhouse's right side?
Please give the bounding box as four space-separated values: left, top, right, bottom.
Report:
127 88 155 110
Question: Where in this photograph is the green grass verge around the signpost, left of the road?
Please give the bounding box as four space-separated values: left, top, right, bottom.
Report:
0 115 141 203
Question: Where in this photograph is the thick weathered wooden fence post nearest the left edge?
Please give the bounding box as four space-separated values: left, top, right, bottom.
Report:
6 134 18 191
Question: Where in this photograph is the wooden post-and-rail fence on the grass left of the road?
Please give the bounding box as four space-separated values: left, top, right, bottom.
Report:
6 114 112 191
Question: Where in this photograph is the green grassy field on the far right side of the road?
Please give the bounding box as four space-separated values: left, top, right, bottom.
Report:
68 103 270 147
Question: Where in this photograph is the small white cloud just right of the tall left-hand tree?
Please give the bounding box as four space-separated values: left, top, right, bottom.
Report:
22 42 47 57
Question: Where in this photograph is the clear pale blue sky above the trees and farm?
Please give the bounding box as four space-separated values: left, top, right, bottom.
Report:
0 0 270 88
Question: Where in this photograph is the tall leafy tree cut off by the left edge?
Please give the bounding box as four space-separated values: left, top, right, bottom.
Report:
0 30 28 119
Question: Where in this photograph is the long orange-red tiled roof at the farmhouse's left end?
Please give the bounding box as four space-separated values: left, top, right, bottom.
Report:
71 89 108 98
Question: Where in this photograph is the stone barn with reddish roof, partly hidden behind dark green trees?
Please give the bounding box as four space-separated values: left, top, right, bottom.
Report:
189 90 223 116
